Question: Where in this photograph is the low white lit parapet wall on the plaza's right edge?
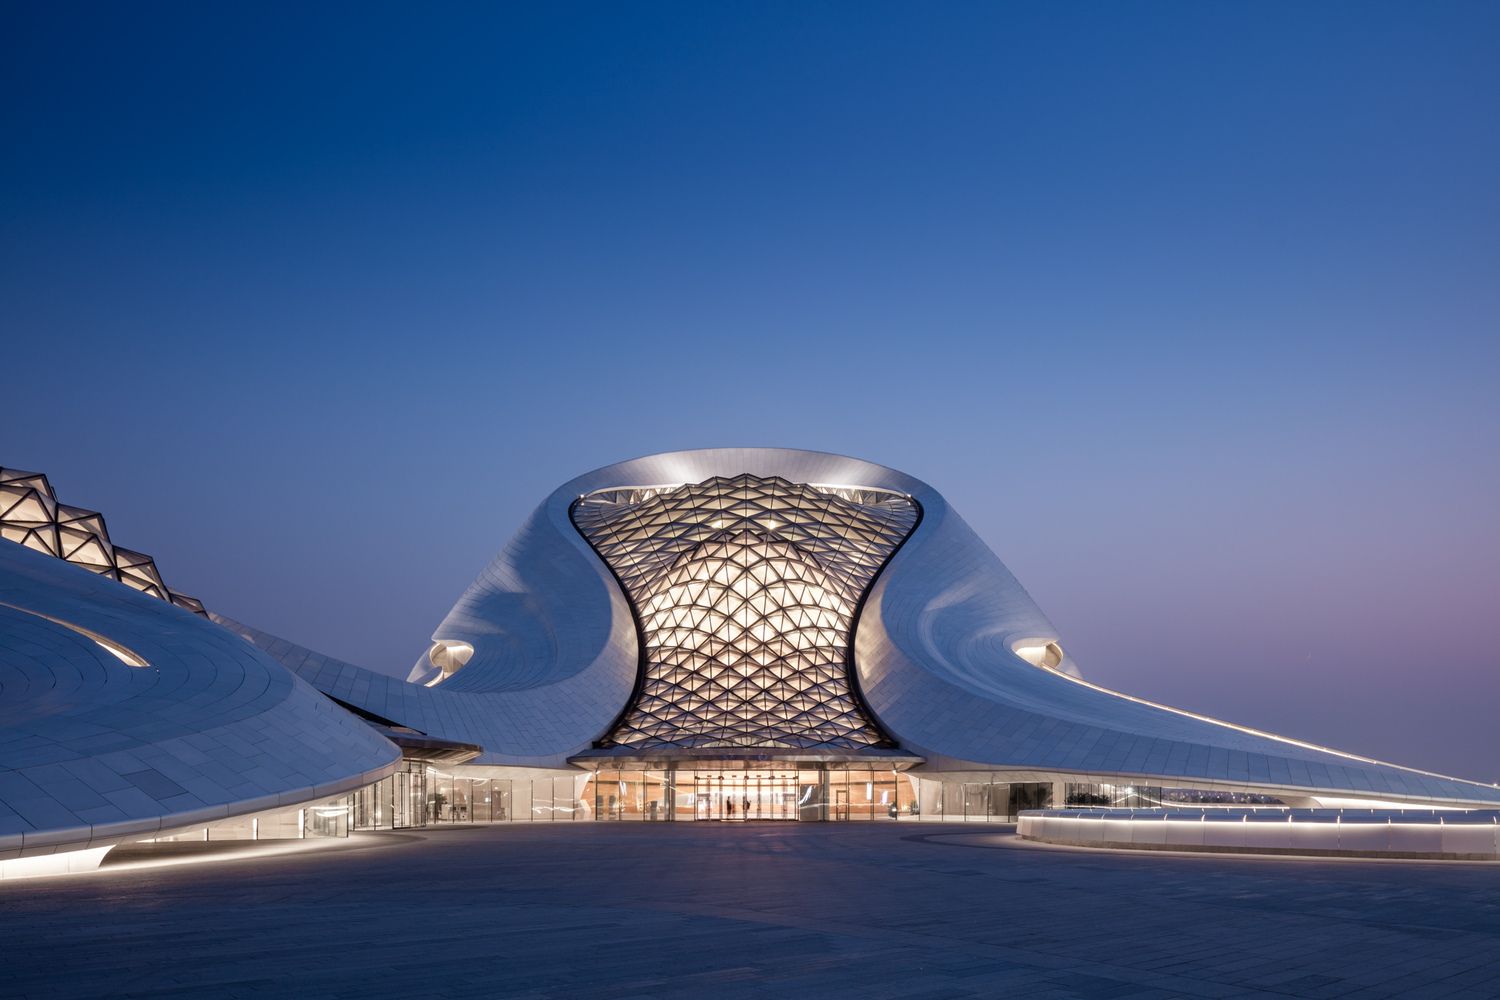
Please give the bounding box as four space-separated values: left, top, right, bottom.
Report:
1017 808 1500 861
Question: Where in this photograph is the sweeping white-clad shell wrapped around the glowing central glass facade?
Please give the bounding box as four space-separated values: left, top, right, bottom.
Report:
225 448 1500 804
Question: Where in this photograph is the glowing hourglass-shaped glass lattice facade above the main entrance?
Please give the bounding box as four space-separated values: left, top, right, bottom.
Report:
572 475 920 750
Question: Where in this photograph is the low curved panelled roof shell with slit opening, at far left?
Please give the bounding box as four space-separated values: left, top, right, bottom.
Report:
0 543 401 859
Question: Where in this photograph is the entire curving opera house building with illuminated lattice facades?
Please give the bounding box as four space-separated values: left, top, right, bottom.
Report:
0 448 1500 876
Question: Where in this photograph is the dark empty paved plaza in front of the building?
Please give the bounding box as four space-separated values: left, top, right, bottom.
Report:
0 823 1500 1000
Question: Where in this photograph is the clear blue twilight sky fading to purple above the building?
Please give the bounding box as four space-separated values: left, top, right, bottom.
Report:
0 1 1500 781
